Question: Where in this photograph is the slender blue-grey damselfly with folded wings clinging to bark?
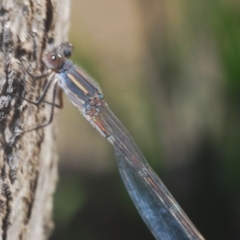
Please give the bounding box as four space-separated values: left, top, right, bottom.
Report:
19 42 204 240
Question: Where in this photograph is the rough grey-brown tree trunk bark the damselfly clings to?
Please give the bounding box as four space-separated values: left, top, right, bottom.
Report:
0 0 69 240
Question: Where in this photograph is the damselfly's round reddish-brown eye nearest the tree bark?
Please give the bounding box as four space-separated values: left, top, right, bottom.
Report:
42 51 65 72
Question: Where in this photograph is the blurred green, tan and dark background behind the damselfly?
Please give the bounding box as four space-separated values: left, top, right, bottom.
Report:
51 0 240 240
